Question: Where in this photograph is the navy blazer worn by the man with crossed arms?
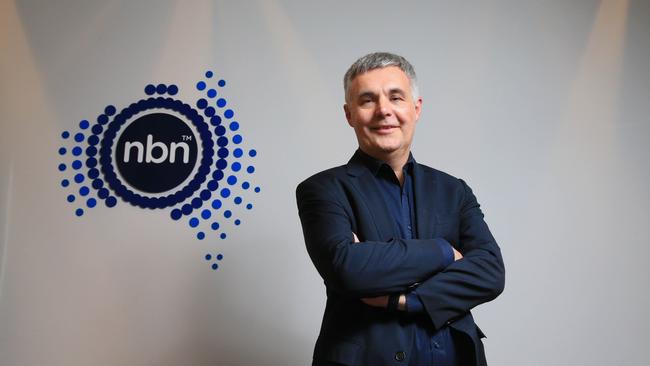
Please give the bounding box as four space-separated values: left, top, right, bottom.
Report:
296 152 505 366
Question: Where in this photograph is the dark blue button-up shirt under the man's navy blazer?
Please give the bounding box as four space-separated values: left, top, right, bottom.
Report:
354 149 457 366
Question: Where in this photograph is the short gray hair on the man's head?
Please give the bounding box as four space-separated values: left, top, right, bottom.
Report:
343 52 420 102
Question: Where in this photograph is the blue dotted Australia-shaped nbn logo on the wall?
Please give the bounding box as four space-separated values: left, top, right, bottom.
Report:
58 71 260 270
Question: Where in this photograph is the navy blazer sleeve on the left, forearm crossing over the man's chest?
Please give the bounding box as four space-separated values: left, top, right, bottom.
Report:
296 178 449 298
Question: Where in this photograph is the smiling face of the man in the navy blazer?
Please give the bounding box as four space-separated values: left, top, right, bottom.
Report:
343 66 422 158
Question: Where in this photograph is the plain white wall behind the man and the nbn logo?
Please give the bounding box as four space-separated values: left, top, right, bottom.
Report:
0 0 650 366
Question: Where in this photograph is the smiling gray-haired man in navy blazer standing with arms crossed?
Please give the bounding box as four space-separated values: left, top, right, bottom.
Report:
296 53 504 366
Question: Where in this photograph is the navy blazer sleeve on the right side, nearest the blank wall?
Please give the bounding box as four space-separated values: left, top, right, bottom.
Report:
417 180 505 329
